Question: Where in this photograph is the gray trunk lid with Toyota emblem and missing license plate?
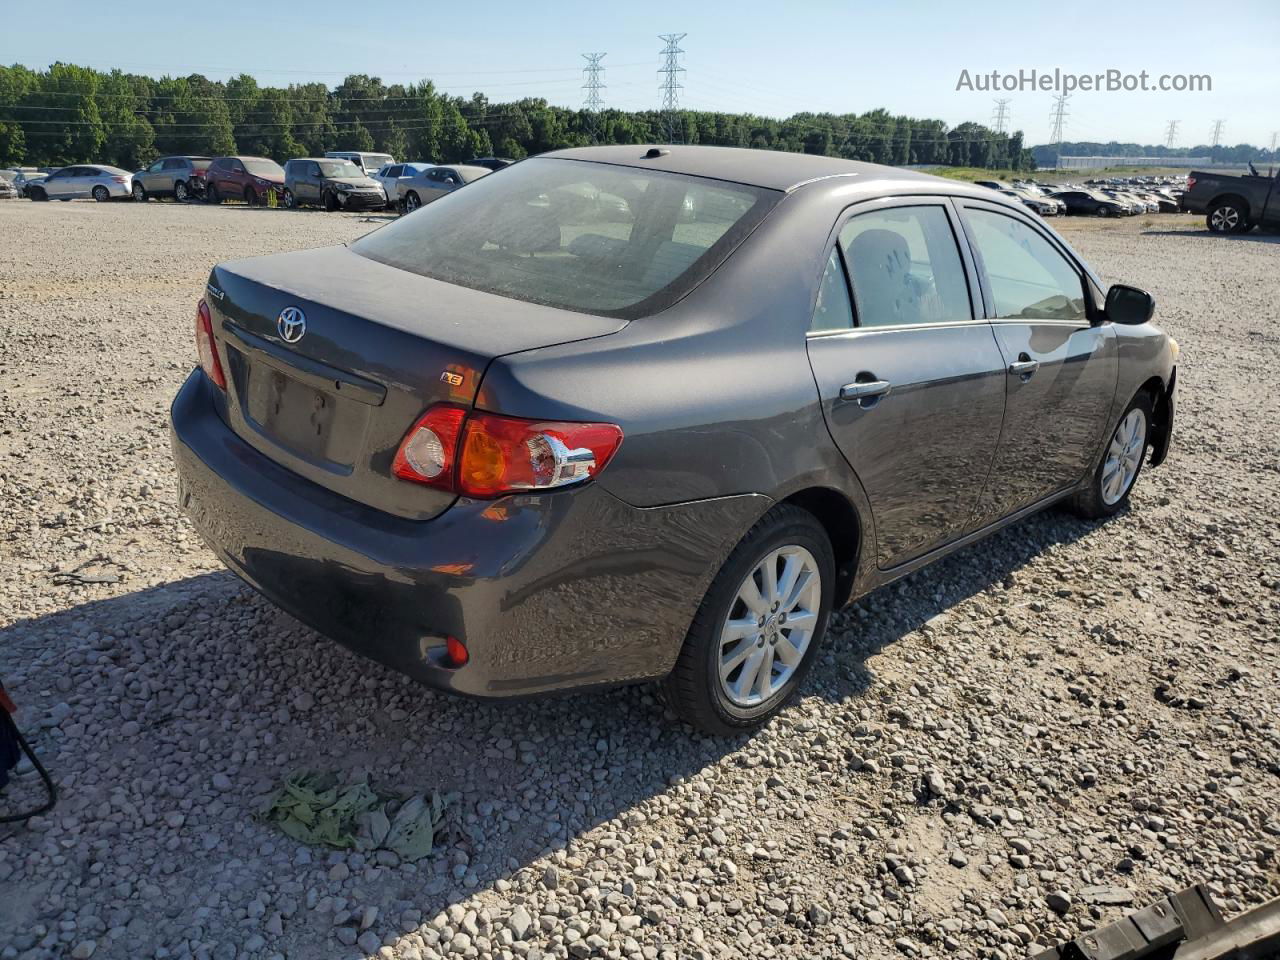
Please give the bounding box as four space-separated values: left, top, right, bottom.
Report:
206 247 625 520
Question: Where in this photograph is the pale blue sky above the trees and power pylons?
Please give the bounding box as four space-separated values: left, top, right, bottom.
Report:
10 0 1280 146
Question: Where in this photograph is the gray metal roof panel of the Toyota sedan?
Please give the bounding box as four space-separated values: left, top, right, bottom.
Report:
541 143 952 196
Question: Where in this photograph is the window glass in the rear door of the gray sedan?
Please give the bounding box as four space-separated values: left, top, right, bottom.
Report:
840 205 973 326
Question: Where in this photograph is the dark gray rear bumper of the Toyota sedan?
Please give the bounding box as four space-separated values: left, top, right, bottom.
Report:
170 370 769 696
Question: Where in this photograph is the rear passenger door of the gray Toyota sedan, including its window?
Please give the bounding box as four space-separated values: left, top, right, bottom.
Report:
808 197 1005 568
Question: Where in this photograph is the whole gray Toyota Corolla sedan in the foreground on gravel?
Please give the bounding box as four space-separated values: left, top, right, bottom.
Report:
172 146 1178 733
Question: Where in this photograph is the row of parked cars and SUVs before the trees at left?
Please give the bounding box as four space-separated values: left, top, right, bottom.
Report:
0 151 512 212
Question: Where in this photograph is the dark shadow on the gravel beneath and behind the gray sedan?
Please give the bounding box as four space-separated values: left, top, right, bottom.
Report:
0 499 1098 955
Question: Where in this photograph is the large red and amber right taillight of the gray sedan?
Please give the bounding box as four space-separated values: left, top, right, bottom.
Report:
392 404 622 499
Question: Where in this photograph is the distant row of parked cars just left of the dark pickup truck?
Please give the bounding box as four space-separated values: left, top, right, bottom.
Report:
977 177 1187 216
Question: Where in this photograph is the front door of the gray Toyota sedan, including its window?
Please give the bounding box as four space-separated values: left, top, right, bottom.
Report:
960 200 1119 516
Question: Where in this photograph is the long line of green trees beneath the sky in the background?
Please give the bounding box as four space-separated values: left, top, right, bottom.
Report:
0 63 1034 170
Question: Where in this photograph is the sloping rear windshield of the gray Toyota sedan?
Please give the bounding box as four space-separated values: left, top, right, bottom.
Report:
352 157 782 319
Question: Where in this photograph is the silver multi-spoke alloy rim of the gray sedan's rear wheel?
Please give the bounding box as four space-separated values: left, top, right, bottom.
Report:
719 544 822 707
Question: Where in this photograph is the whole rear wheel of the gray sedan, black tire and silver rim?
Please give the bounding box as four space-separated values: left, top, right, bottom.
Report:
663 504 836 736
